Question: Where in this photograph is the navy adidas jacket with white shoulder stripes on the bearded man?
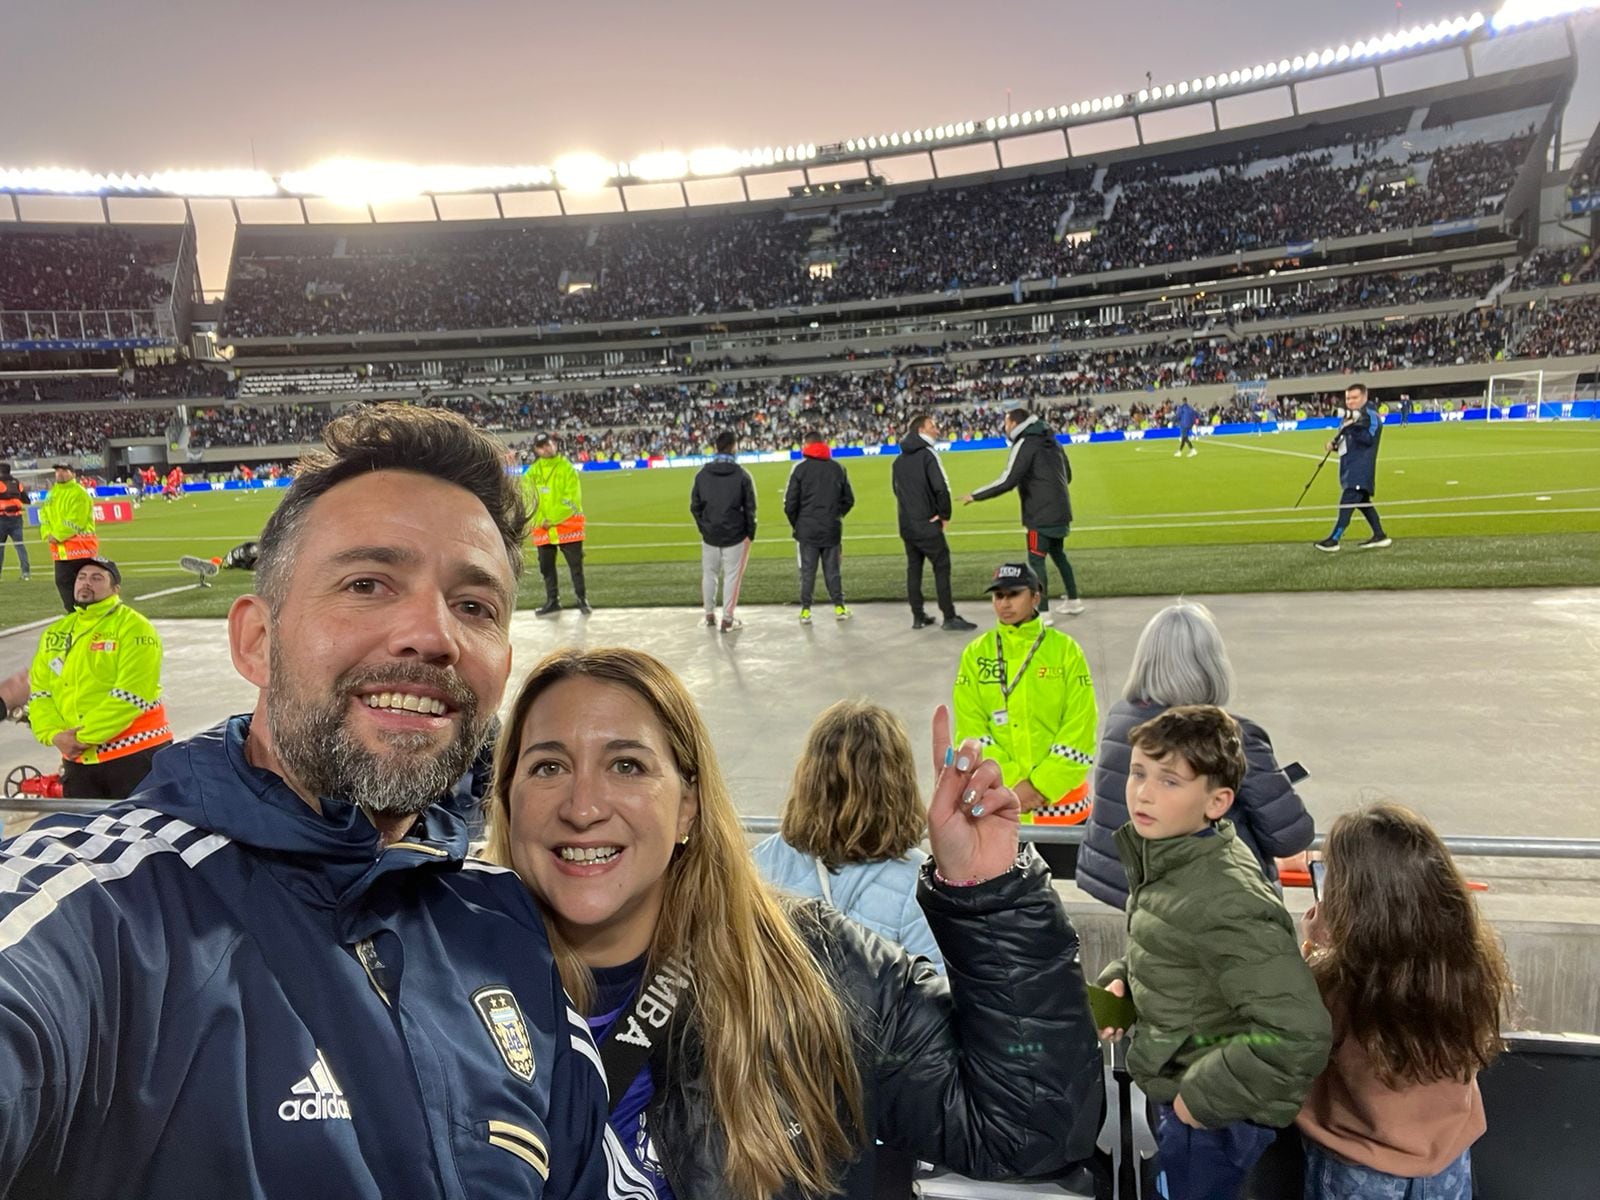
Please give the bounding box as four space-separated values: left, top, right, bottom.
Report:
0 717 613 1200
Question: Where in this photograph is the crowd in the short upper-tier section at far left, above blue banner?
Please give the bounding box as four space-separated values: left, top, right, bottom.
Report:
0 226 174 312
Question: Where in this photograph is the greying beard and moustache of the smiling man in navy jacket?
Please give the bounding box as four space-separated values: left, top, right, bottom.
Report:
267 642 488 816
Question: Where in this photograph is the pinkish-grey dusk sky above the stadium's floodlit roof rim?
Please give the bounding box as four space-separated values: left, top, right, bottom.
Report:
0 0 1600 173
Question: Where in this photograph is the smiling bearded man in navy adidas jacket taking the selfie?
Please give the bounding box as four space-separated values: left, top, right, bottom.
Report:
0 406 616 1200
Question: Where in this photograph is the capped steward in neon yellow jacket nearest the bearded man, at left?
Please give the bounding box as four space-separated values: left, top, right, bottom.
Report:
27 558 173 800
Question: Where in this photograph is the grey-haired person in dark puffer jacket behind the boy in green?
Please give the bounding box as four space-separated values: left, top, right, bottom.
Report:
1077 602 1315 909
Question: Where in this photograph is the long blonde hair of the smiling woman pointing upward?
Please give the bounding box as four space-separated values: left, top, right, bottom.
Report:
490 648 867 1200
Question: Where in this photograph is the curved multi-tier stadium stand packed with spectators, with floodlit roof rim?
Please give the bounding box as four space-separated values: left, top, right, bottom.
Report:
0 8 1600 474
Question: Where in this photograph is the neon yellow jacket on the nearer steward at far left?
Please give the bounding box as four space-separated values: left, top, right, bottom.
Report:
27 595 173 763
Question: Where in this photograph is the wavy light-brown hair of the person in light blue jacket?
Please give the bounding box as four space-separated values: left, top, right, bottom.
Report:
782 701 928 870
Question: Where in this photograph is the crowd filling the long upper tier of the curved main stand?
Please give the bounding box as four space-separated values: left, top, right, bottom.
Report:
226 133 1533 336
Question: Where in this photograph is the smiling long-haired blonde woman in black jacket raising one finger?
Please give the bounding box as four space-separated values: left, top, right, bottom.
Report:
490 650 1101 1200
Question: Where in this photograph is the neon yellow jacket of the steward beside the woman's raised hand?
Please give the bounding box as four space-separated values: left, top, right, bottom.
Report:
955 618 1099 826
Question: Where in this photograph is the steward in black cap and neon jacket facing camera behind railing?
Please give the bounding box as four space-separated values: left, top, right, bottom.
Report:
955 563 1099 877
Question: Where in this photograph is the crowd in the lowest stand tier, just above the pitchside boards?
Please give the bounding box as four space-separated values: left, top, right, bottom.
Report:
12 289 1600 458
